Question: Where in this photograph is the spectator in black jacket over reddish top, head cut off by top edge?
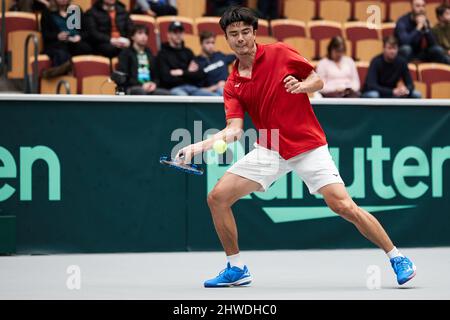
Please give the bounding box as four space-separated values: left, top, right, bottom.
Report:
86 0 133 58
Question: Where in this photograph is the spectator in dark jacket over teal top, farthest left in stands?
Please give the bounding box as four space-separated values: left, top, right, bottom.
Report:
41 0 92 78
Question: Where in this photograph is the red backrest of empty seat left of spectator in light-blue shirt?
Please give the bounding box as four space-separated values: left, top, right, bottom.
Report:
72 55 111 93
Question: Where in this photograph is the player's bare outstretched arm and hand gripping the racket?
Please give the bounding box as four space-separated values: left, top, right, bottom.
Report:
176 118 244 163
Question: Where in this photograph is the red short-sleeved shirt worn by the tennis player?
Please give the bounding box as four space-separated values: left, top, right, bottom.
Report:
224 42 327 159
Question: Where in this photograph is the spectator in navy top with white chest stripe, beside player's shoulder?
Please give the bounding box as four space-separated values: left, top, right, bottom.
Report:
194 31 236 96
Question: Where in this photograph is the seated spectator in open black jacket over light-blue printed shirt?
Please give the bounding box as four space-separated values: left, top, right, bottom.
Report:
117 24 170 95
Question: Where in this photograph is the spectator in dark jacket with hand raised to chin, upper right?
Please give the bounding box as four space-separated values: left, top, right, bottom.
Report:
395 0 450 63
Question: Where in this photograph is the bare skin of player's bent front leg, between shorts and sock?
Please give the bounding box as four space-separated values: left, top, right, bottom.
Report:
208 172 261 256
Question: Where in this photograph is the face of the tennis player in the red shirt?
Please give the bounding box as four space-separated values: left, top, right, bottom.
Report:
226 22 256 55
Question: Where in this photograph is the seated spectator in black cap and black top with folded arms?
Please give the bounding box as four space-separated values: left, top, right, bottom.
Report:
158 21 214 96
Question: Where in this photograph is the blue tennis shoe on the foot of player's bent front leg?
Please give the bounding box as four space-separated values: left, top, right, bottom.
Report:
204 263 253 288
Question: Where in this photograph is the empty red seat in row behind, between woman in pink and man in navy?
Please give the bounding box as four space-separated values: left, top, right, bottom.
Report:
344 22 381 61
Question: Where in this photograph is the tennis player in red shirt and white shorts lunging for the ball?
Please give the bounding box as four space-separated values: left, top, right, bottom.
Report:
177 7 416 287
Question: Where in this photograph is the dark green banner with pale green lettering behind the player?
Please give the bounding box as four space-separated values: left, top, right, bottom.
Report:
0 97 450 253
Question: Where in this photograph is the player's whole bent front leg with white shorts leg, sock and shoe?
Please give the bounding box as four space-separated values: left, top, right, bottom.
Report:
204 147 287 287
